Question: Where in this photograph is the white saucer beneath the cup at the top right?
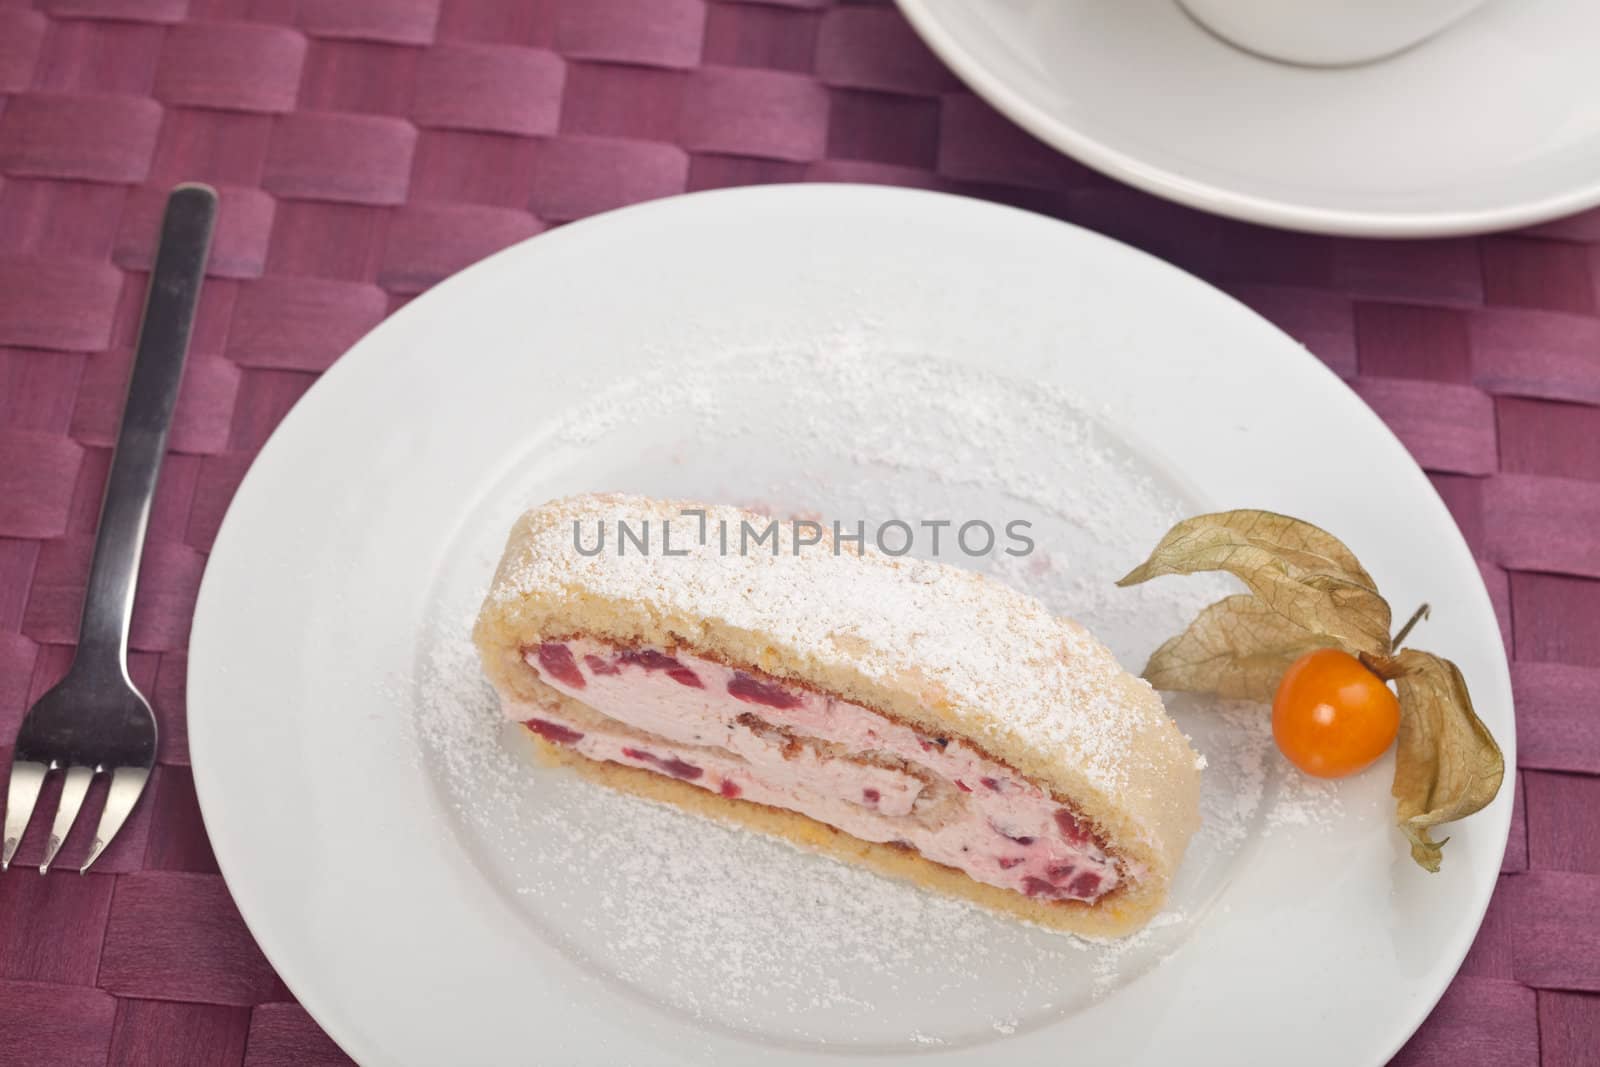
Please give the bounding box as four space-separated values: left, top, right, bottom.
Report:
899 0 1600 237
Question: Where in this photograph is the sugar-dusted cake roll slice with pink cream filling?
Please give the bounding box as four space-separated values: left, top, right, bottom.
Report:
474 496 1200 936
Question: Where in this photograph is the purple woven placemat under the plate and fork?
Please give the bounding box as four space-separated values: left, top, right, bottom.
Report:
0 0 1600 1067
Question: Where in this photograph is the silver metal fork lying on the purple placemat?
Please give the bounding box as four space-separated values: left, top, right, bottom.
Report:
0 184 216 873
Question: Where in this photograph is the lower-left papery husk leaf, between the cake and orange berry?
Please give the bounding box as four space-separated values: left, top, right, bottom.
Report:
1144 593 1338 704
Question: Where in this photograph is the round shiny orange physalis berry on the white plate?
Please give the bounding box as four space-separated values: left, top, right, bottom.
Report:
1272 648 1400 777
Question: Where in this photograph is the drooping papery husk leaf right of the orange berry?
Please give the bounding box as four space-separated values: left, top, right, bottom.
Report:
1382 648 1506 872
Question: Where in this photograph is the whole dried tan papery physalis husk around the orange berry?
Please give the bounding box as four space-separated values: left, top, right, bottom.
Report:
1117 510 1506 870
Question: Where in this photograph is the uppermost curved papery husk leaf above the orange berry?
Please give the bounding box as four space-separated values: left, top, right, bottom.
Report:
1117 510 1390 653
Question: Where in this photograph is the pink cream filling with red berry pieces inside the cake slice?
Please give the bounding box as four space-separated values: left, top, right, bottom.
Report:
518 638 1122 901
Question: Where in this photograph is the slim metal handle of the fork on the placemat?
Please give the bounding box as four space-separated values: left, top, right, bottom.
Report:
77 184 216 670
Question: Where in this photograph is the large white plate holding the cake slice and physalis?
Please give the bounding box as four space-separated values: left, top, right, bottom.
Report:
189 186 1515 1064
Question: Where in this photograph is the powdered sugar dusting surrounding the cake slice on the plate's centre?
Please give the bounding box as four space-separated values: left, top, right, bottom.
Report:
411 347 1350 1051
